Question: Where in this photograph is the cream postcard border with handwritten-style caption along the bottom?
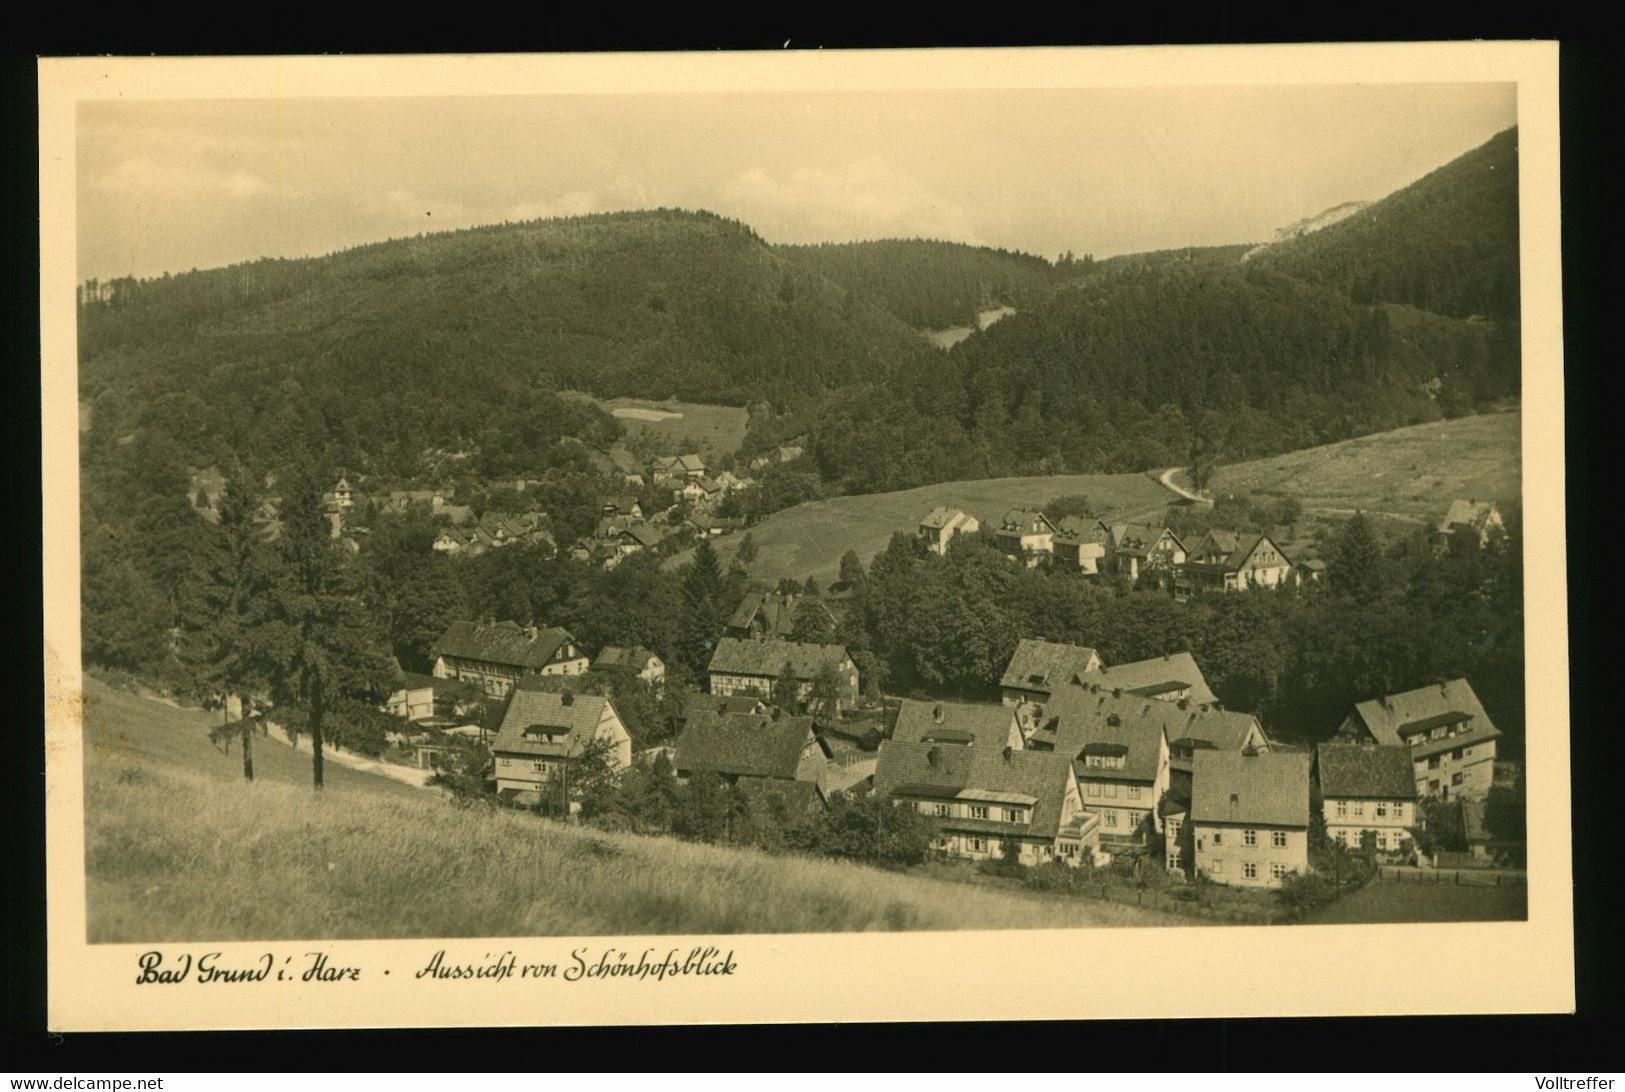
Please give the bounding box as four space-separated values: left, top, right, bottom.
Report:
39 42 1575 1032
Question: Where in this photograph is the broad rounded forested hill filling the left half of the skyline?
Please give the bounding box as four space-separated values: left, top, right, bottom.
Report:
80 210 930 471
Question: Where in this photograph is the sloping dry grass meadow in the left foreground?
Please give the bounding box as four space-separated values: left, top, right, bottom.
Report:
85 679 1188 943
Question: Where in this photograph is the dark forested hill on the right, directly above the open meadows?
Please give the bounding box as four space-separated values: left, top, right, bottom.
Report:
814 265 1518 491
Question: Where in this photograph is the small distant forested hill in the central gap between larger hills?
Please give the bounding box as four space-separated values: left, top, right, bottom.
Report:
775 239 1089 330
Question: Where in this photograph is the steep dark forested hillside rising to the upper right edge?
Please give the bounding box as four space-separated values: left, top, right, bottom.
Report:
1251 128 1519 322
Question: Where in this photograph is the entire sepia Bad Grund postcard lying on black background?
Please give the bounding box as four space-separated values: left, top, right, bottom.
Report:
31 44 1573 1027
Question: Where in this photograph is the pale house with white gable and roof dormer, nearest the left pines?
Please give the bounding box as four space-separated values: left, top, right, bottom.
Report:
491 684 632 811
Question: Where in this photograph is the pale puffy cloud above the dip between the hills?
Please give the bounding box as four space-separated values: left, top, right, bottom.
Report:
722 158 982 242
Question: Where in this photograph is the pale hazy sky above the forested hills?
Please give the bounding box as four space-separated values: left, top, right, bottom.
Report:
76 83 1518 281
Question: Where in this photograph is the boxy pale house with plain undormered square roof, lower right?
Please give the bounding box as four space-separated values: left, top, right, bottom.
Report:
1190 748 1310 887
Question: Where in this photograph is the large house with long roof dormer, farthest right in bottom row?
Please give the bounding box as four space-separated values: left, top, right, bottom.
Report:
1334 679 1502 800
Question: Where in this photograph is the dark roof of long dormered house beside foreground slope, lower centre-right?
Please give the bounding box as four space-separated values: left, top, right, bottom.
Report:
874 739 1071 839
